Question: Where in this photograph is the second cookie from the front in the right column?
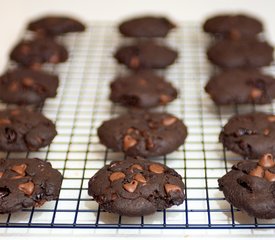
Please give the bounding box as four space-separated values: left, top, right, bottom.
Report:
220 113 275 158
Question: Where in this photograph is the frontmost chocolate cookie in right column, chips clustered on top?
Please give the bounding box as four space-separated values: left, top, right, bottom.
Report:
218 154 275 219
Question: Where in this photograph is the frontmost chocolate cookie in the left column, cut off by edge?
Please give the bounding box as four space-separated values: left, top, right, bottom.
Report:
0 158 62 213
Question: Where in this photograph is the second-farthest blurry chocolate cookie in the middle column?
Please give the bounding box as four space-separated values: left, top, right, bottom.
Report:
114 41 178 69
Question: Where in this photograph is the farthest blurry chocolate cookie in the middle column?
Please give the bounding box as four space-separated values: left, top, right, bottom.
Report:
119 16 175 37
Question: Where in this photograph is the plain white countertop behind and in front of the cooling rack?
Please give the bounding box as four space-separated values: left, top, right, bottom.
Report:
0 0 275 239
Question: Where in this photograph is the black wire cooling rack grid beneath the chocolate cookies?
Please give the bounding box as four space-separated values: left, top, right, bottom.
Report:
0 22 275 229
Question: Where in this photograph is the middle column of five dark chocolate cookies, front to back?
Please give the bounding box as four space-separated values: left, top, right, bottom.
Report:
88 16 187 216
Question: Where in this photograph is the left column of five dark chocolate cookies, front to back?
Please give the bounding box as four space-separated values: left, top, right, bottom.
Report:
0 16 84 213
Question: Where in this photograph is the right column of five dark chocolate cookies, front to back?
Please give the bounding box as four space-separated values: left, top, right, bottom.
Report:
204 15 275 219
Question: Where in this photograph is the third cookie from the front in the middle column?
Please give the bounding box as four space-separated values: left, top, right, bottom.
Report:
110 70 177 108
